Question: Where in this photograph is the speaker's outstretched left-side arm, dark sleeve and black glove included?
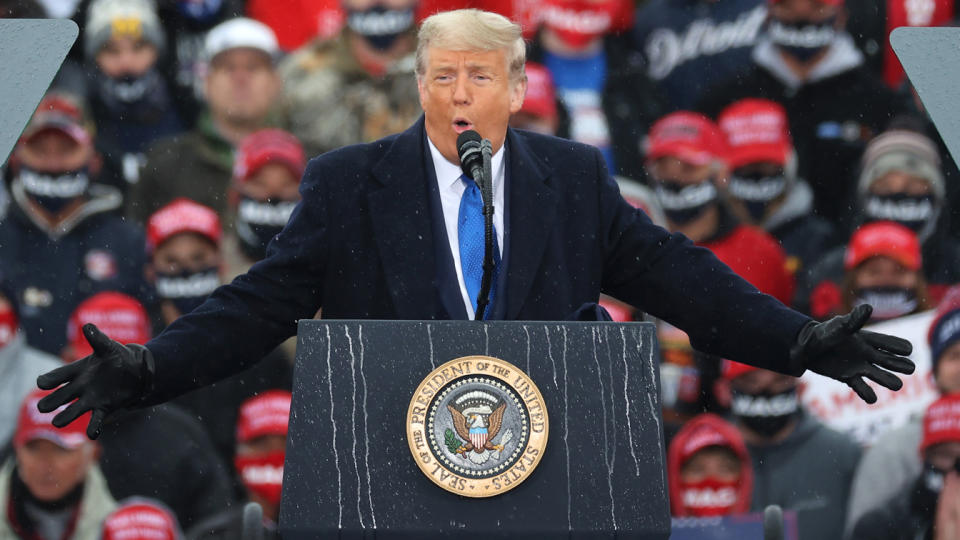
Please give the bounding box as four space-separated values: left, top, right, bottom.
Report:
37 156 329 438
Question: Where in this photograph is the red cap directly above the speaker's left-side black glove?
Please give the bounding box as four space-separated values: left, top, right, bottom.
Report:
67 292 152 361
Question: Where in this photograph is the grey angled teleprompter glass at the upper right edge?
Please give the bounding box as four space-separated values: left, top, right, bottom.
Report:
890 27 960 168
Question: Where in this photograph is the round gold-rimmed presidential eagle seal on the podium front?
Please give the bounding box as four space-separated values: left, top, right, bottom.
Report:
407 356 549 497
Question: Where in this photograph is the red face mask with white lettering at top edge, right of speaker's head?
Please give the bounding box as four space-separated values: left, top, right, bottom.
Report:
543 0 620 49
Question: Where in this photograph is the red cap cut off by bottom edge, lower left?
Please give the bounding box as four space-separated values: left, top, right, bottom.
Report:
101 498 183 540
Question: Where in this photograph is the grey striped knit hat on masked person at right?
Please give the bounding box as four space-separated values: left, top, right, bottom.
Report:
857 129 945 201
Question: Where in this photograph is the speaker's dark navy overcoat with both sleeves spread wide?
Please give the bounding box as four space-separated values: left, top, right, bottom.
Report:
147 118 809 402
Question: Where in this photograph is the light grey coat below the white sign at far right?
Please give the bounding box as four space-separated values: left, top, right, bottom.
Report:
847 416 923 531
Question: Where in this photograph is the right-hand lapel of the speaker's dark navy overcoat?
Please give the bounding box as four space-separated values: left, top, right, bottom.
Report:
505 129 557 320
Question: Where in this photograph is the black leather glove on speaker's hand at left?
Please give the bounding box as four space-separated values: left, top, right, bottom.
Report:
37 324 155 439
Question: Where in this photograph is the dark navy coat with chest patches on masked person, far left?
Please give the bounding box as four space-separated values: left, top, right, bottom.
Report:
0 181 150 355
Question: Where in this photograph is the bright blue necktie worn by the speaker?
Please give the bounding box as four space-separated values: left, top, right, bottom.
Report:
457 175 500 319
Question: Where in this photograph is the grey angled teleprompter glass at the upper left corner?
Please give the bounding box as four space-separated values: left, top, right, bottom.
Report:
0 19 79 164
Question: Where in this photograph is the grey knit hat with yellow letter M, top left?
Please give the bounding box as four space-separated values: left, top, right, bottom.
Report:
83 0 166 61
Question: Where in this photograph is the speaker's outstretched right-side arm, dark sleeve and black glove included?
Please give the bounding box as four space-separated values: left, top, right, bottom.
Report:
597 153 914 403
